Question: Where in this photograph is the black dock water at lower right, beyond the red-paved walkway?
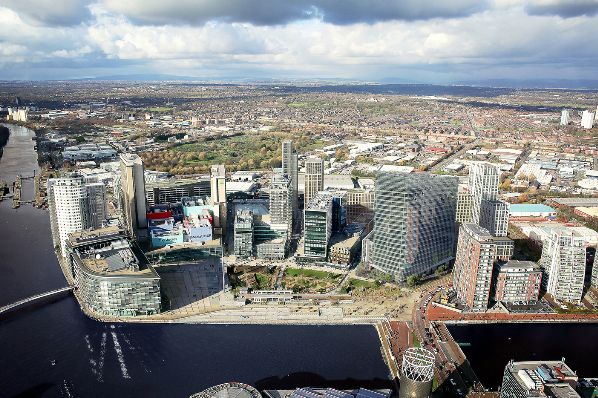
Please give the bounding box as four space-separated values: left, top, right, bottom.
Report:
449 323 598 389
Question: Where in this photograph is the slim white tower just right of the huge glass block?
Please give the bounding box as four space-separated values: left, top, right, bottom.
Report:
469 162 500 225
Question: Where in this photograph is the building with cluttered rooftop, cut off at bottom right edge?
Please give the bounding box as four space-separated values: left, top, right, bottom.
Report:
500 359 580 398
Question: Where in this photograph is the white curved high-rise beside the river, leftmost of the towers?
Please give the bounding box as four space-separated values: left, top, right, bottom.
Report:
48 174 88 258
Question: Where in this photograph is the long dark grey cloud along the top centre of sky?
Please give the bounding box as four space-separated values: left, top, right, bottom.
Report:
102 0 487 26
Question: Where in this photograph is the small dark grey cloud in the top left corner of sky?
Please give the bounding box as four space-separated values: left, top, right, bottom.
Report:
0 0 91 26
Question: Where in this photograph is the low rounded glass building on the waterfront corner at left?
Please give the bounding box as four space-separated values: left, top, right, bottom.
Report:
67 227 161 316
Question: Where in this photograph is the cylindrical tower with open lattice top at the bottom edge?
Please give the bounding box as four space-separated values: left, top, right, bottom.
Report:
399 347 435 398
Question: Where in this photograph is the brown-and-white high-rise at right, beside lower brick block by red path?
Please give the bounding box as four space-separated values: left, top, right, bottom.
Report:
453 224 513 311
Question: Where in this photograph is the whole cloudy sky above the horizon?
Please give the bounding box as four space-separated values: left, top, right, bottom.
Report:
0 0 598 83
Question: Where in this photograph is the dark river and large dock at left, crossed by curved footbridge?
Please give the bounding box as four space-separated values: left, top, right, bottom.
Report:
0 126 391 397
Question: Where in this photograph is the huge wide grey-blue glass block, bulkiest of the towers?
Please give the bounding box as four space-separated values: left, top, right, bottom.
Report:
372 173 458 281
